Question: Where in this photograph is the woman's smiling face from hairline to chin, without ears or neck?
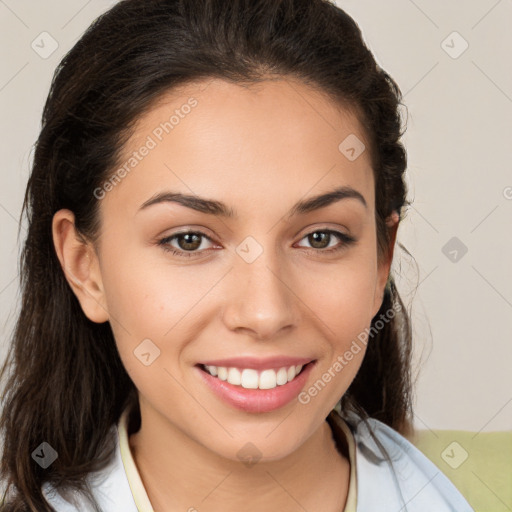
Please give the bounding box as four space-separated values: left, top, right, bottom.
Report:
86 80 388 460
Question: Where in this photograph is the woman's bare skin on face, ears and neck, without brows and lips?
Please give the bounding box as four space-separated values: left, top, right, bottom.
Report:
53 78 398 512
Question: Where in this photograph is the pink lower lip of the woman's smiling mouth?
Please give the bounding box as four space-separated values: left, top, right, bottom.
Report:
196 361 315 412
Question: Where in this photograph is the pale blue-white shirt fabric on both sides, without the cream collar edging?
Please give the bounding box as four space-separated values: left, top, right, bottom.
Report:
43 413 474 512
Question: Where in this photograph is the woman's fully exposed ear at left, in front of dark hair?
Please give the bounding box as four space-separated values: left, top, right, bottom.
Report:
52 210 109 323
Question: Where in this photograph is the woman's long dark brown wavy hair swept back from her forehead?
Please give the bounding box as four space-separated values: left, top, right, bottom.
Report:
0 0 412 512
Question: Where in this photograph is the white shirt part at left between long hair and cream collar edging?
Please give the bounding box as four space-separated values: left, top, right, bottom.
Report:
42 426 137 512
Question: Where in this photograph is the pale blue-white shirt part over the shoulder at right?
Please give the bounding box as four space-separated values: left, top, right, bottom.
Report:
347 418 473 512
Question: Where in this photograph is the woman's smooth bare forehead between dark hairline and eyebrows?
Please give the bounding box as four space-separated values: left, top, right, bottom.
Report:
103 78 374 218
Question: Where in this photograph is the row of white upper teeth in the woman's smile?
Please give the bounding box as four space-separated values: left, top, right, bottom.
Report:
205 364 302 389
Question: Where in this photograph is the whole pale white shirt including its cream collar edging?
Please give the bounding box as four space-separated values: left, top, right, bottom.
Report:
42 410 474 512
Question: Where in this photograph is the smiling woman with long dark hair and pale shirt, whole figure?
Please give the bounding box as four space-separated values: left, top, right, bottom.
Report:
1 0 471 512
